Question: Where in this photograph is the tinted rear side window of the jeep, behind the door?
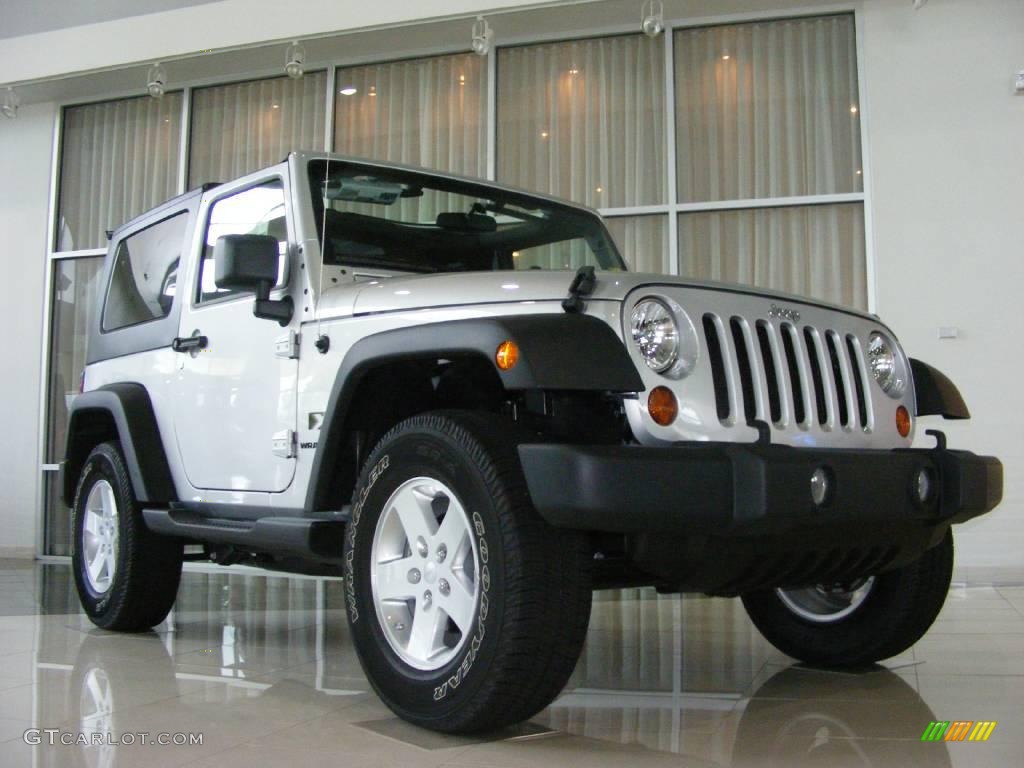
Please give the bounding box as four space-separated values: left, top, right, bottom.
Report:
103 211 188 331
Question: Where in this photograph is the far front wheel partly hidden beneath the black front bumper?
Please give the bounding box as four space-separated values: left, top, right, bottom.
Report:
742 530 953 668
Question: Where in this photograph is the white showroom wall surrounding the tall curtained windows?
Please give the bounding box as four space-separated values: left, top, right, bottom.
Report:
0 0 1024 578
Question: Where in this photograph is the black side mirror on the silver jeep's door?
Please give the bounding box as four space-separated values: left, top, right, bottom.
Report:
213 234 295 326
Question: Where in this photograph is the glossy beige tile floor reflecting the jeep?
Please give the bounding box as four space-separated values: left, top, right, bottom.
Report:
0 561 1024 768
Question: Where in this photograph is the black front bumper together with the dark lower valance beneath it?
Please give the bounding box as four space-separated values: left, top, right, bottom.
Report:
519 438 1002 595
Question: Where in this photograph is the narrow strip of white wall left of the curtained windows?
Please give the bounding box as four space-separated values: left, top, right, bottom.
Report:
0 104 56 557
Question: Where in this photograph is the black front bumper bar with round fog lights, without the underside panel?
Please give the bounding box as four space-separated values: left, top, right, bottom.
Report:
519 442 1002 537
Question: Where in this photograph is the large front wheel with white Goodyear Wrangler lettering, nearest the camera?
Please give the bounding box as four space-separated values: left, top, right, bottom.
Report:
344 411 591 733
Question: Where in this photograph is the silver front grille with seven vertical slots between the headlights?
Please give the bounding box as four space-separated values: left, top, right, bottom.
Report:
702 312 873 431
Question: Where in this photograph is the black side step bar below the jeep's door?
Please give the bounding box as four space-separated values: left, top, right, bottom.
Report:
142 509 345 560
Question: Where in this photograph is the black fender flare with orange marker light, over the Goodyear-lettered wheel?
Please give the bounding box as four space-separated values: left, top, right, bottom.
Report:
305 313 644 511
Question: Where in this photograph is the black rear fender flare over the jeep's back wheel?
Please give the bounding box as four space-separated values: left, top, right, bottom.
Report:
61 382 177 507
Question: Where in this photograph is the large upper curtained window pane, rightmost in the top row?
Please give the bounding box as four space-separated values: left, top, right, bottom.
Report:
675 15 863 203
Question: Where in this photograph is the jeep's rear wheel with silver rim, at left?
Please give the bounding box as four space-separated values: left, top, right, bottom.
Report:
72 442 182 632
